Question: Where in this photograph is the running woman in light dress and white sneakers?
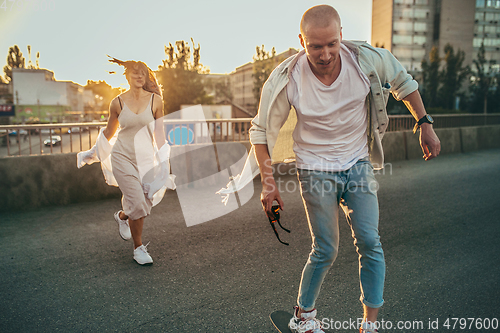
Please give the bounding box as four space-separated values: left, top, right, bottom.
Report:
78 58 175 265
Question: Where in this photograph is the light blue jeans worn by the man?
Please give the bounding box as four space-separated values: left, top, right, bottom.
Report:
297 158 385 311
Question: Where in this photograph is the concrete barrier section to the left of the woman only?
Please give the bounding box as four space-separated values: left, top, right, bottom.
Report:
0 153 120 212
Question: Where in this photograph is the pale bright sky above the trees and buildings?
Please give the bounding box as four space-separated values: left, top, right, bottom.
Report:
0 0 372 88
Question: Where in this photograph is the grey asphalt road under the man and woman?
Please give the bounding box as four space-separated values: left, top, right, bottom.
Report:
0 150 500 333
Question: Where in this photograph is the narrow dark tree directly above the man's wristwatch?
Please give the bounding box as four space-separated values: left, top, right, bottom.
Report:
422 46 441 107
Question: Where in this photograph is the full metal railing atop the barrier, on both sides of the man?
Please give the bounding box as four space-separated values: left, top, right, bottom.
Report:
0 114 500 157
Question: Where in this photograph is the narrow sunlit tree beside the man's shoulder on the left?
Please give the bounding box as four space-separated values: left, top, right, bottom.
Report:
252 45 277 107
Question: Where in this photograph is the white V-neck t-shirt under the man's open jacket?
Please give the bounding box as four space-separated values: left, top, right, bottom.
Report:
287 44 370 171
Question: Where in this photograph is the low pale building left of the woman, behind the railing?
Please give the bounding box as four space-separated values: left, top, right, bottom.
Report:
12 68 84 122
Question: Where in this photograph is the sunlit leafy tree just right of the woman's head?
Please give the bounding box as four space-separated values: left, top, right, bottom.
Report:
157 38 212 114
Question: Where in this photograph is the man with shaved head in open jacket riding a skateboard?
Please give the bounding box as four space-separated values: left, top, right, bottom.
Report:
250 5 440 332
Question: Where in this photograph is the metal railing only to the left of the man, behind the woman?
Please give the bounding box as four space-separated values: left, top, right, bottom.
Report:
0 118 252 157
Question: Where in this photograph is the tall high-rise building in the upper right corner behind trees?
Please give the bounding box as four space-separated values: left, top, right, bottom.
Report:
371 0 500 73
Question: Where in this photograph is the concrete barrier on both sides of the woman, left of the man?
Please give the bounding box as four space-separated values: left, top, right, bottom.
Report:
0 142 250 212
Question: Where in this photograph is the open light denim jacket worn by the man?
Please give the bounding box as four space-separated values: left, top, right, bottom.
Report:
250 41 418 169
